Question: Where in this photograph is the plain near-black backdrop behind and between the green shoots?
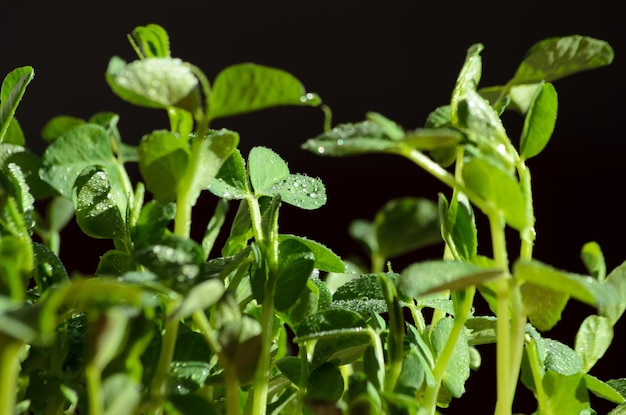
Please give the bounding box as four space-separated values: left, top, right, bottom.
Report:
0 0 626 413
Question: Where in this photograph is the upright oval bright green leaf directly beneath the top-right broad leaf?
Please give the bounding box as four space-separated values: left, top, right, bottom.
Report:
520 83 558 159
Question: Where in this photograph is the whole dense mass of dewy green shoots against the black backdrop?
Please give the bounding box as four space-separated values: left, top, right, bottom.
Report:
0 24 626 415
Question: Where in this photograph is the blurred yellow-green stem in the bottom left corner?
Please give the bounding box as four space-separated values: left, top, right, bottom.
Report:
0 333 23 415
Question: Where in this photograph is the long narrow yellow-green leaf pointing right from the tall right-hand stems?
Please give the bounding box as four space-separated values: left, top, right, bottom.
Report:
513 260 618 307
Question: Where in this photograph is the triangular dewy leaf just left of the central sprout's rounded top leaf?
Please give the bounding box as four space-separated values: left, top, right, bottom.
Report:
208 149 250 200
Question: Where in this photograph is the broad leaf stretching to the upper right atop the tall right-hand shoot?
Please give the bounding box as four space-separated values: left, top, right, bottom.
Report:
509 35 614 85
